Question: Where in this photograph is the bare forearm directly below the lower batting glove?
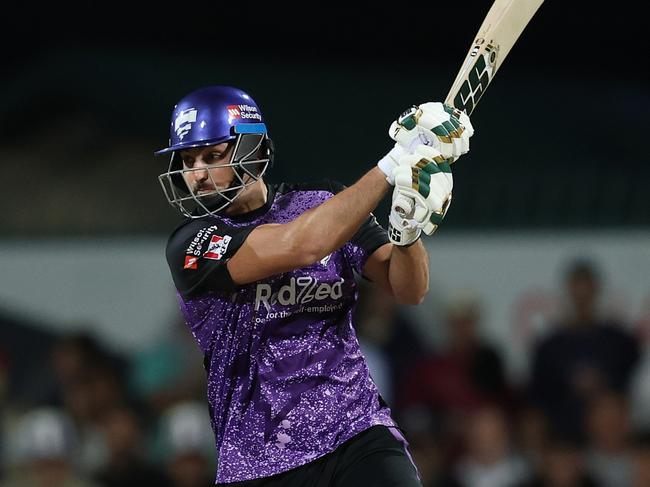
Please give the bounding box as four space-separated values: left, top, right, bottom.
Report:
388 240 429 304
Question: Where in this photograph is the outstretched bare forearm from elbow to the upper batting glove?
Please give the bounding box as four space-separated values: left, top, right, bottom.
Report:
291 167 391 261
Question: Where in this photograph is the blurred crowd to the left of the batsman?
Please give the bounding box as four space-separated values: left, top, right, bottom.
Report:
0 323 216 487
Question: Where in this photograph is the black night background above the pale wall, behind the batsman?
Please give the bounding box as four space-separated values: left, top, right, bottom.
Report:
0 1 650 236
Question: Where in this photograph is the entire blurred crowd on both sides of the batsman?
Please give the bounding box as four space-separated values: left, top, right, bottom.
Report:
0 260 650 487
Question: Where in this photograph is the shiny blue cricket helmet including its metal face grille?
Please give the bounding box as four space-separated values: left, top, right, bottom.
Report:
155 86 274 218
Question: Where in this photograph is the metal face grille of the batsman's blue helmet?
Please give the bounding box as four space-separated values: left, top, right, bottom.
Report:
158 134 273 218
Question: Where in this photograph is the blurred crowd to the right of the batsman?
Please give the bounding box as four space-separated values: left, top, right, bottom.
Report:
359 260 650 487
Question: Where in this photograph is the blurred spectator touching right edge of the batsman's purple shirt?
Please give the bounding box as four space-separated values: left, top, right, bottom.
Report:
354 281 424 406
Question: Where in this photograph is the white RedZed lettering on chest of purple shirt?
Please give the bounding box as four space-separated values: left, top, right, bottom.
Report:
255 276 345 311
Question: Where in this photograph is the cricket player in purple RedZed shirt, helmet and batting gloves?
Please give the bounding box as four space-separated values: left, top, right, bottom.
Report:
156 86 473 487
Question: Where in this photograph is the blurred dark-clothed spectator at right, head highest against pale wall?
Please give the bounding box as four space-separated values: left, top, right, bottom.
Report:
531 261 639 439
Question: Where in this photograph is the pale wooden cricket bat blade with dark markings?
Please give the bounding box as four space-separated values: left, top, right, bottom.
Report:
445 0 544 115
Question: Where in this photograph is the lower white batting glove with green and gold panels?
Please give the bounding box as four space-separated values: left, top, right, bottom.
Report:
388 144 454 246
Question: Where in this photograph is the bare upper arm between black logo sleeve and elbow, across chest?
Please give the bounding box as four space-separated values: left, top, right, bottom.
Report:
227 223 312 285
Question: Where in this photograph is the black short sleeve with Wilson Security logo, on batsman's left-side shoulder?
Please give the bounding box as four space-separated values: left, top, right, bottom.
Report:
166 220 255 298
